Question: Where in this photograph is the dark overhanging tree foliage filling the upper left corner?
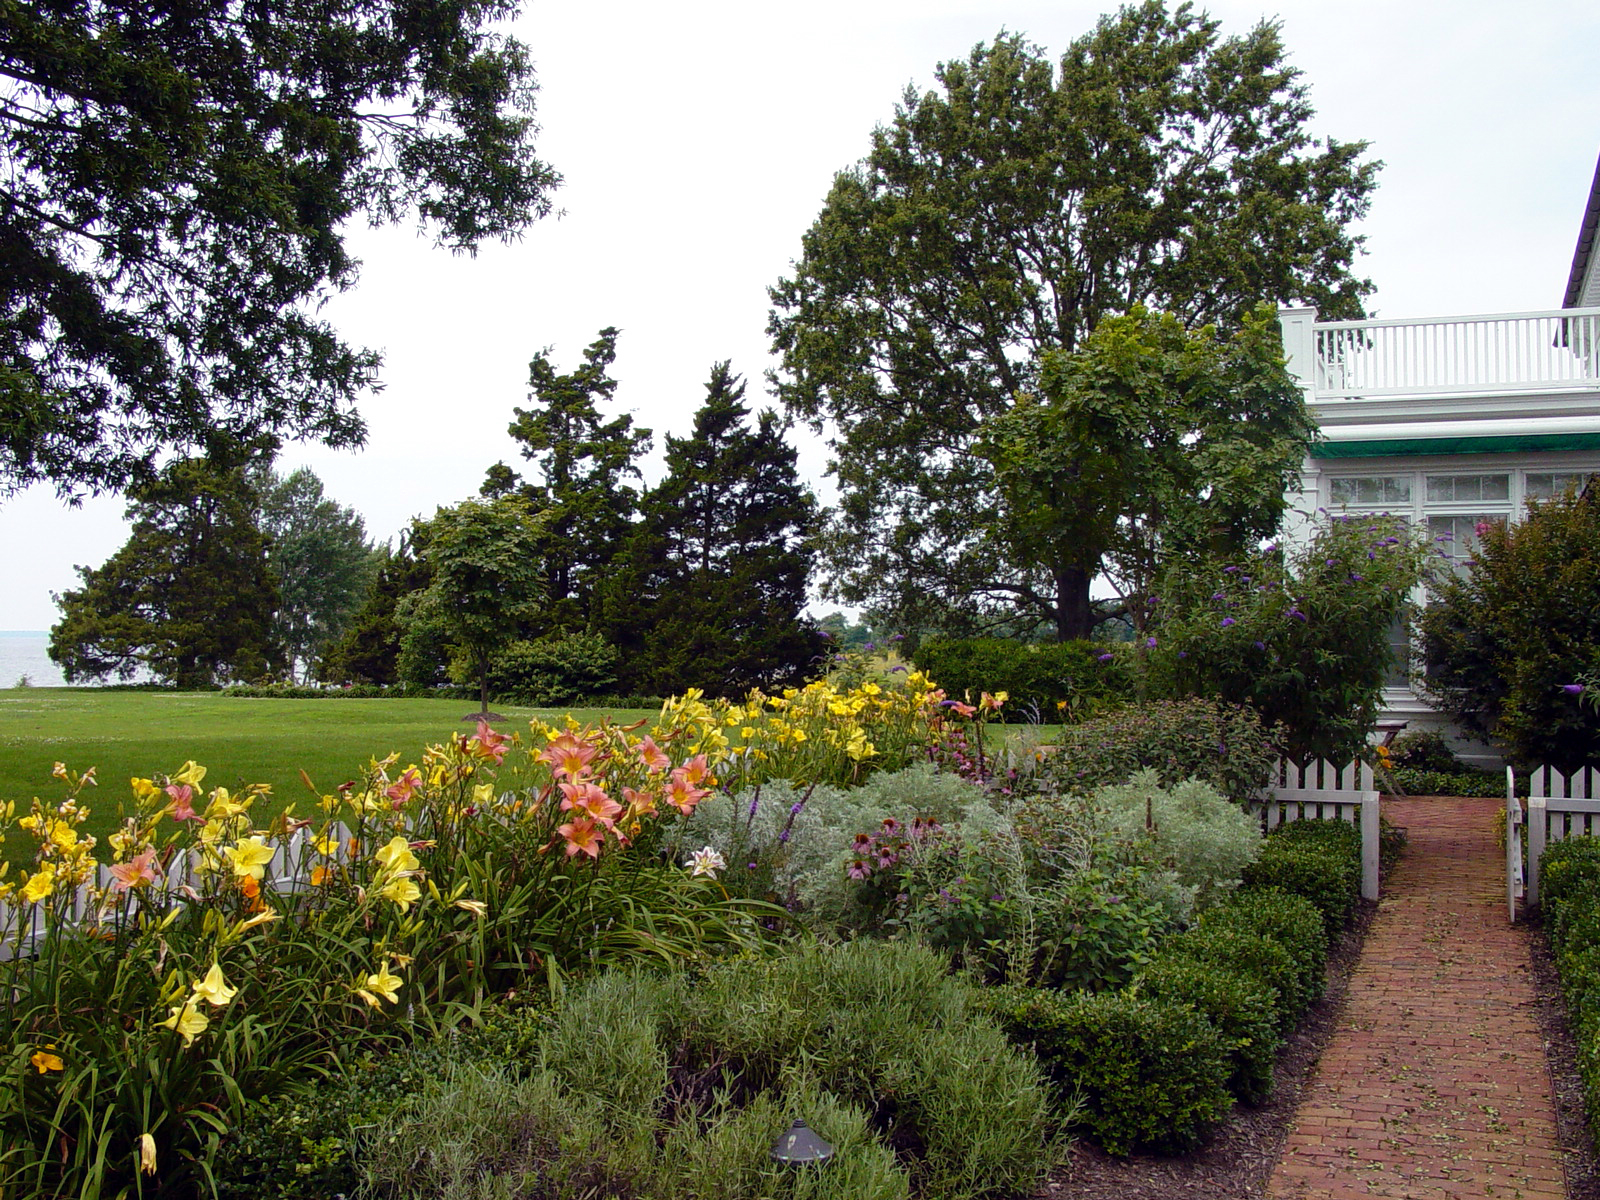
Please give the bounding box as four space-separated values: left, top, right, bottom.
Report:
0 0 558 496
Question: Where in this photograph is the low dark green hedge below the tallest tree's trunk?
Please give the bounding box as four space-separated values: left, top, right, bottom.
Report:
914 637 1131 722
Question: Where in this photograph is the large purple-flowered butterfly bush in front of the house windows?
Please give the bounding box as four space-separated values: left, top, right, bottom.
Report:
1147 515 1432 762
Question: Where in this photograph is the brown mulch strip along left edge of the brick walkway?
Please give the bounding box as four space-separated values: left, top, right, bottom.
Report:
1035 901 1382 1200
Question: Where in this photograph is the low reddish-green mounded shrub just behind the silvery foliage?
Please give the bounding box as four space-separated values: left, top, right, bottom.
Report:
1042 699 1277 802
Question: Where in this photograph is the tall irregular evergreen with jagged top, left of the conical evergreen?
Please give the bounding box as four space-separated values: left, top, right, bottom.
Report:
482 328 650 635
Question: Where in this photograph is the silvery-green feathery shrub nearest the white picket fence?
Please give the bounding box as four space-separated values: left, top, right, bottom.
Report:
1090 770 1261 909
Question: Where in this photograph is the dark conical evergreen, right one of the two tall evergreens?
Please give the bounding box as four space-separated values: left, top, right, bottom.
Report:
606 362 826 696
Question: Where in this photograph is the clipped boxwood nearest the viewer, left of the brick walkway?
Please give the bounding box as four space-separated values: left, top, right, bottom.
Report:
984 987 1232 1155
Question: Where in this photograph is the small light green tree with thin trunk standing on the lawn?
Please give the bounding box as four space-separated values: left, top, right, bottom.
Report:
402 496 544 717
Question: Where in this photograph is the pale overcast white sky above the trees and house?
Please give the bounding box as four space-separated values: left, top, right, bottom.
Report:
0 0 1600 630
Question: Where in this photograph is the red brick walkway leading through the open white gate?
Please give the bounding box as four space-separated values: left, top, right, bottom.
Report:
1267 798 1565 1200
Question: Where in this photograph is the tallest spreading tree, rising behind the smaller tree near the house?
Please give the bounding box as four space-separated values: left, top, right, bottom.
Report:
770 0 1376 643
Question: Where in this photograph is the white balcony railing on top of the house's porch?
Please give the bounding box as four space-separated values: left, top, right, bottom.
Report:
1312 309 1600 398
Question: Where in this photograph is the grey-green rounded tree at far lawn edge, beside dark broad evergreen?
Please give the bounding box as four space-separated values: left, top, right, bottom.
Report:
258 467 378 674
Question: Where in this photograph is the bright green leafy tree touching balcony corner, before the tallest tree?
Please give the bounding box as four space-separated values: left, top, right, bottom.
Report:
972 307 1315 640
